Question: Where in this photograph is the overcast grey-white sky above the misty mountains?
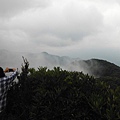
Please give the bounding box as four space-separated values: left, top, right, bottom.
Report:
0 0 120 65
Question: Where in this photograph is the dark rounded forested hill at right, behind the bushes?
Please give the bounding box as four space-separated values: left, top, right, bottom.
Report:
79 59 120 77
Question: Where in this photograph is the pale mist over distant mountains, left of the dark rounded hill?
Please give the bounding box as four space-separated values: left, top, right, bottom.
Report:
0 50 101 73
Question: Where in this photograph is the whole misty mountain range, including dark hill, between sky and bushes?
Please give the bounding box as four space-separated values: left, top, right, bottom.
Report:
0 50 120 77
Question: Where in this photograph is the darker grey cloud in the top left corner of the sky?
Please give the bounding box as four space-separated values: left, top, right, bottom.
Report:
0 0 51 18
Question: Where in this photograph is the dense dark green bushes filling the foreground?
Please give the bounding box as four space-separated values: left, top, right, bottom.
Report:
0 60 120 120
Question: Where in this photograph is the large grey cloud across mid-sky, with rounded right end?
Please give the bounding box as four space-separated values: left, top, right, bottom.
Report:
8 1 103 45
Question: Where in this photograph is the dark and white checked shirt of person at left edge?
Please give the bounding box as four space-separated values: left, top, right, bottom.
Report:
0 71 18 112
